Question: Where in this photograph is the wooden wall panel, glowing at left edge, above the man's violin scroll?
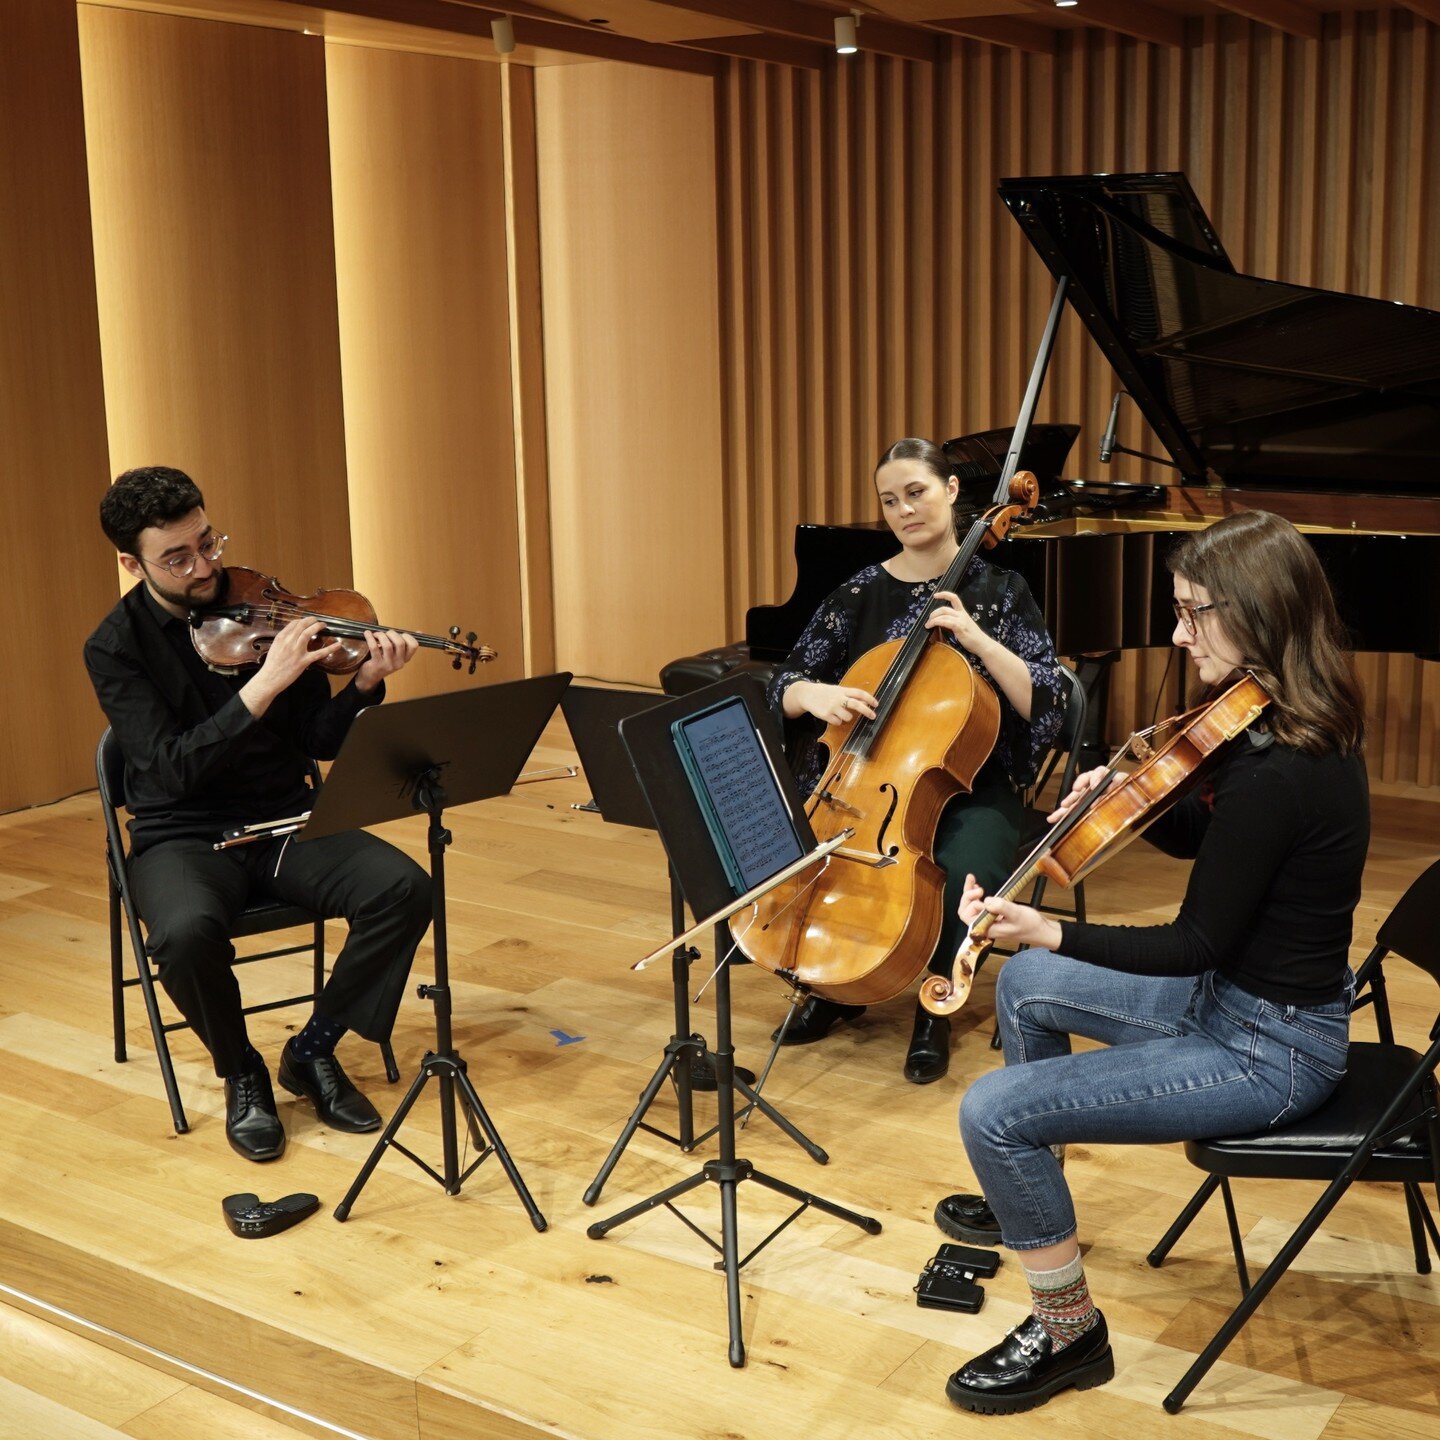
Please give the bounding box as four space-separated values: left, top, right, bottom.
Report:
325 45 524 696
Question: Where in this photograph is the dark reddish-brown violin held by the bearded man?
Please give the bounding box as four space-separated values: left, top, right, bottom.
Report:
190 564 495 675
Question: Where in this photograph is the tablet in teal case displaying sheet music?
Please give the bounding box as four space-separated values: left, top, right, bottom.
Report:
681 698 805 890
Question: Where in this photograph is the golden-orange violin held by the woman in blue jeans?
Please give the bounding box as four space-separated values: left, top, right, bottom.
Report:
920 672 1270 1015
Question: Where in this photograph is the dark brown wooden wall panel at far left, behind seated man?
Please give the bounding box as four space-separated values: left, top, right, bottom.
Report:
0 0 115 811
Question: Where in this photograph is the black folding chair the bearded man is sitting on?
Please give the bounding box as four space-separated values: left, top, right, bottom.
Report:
95 729 400 1135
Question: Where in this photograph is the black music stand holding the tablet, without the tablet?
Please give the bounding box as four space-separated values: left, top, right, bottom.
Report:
586 675 880 1368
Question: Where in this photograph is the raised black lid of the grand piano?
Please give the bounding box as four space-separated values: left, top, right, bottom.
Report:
999 173 1440 495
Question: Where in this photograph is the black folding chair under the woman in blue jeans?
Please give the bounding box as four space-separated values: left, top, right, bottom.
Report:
1146 861 1440 1416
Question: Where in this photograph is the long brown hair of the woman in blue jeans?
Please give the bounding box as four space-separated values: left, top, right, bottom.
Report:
1166 510 1365 755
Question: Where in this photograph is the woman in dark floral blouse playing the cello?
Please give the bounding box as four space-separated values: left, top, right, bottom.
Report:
770 439 1064 1084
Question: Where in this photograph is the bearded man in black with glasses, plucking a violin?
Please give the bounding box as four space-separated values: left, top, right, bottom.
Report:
85 465 431 1161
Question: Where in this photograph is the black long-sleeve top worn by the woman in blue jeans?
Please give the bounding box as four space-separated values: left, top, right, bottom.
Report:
1060 733 1369 1005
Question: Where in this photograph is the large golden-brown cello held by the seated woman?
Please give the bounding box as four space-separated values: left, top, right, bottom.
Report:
734 471 1038 1005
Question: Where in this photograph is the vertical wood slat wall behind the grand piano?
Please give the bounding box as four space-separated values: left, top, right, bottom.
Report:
717 10 1440 786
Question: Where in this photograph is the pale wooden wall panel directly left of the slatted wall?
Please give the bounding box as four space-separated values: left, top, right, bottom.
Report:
536 65 725 684
